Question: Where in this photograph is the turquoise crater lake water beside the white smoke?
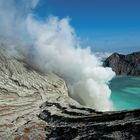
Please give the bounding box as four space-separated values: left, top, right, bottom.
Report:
109 76 140 110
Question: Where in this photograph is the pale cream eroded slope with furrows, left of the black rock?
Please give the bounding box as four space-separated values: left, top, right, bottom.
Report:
0 49 76 140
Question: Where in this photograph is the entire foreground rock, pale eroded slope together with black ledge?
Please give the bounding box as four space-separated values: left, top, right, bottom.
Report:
0 50 140 140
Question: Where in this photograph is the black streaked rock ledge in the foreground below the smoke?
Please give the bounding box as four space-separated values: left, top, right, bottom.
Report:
39 102 140 140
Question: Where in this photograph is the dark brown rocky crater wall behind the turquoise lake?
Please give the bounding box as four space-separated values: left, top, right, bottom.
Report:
103 52 140 76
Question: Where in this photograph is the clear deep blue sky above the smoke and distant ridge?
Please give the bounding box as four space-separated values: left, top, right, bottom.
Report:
35 0 140 53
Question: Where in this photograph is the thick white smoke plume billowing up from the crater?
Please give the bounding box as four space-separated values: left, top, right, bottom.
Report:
0 1 115 111
